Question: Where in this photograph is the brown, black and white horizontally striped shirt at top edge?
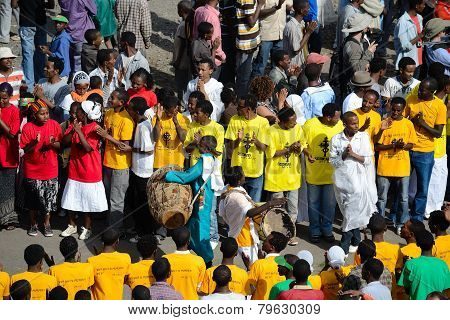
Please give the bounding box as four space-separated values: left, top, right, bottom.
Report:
236 0 261 50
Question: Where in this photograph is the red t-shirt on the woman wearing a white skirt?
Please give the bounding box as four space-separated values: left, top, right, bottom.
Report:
64 122 102 183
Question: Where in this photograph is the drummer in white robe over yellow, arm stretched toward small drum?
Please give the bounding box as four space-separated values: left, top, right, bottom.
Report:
219 166 286 269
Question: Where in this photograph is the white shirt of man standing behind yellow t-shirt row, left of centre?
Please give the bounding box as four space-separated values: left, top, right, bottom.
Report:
183 77 225 122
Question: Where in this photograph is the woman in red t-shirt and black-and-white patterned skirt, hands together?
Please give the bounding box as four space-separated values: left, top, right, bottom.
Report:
20 100 62 237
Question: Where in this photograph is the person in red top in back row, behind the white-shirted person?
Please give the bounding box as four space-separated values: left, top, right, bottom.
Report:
128 68 158 108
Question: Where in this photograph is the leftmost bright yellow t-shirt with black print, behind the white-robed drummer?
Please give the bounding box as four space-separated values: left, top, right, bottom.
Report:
225 115 270 178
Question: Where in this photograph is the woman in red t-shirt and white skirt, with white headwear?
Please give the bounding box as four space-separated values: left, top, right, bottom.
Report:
61 101 108 240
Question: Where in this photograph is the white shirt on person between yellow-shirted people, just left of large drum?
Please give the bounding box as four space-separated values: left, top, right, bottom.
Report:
131 119 155 178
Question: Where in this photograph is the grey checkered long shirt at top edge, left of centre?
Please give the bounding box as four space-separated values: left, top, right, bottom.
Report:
114 0 152 50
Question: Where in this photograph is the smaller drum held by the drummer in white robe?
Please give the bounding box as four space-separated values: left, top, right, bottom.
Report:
253 208 295 241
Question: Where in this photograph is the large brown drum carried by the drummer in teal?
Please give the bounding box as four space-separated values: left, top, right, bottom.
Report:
147 165 192 229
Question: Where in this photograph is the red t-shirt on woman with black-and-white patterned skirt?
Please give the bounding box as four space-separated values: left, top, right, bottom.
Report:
20 119 62 180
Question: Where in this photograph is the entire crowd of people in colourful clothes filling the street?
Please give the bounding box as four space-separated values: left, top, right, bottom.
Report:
0 0 450 300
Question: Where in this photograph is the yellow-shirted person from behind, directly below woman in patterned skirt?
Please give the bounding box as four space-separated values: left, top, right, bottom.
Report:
11 244 57 300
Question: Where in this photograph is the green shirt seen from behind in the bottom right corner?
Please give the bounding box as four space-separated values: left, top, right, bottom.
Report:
398 256 450 300
